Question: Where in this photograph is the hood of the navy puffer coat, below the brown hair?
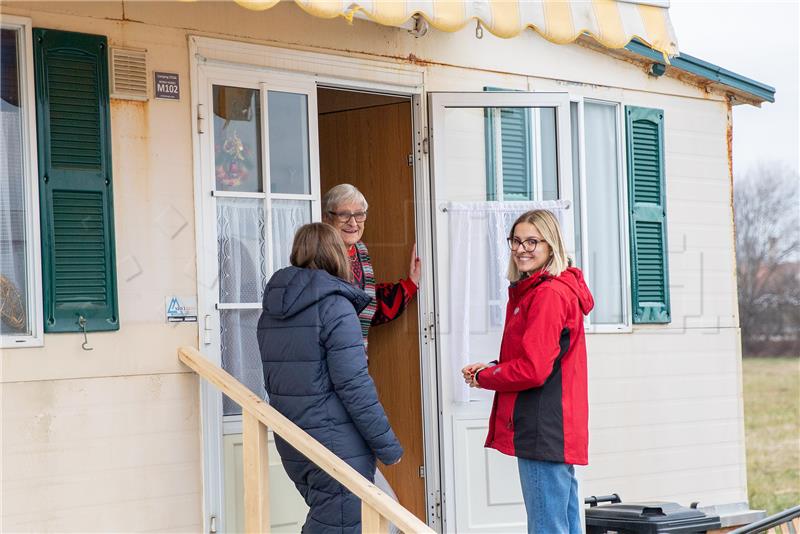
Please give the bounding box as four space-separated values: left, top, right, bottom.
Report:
263 267 370 319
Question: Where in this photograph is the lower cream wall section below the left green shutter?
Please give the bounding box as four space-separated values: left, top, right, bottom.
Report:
0 374 202 532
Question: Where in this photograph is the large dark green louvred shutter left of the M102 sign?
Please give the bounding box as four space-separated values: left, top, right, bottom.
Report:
33 28 119 332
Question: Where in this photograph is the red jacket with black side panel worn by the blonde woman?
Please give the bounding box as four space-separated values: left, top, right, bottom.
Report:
477 267 594 465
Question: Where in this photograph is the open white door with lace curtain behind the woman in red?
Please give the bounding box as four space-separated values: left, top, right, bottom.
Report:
428 92 574 533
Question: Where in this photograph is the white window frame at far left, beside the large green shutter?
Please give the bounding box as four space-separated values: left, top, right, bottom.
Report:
0 15 44 349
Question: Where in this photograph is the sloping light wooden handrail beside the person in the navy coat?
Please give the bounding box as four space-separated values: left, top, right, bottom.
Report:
178 347 434 534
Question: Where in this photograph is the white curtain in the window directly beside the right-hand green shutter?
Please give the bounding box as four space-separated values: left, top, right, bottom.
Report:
584 102 624 324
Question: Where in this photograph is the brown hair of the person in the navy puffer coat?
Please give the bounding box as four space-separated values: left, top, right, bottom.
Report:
289 223 353 282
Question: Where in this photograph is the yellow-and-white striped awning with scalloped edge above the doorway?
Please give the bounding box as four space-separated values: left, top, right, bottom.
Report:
223 0 678 56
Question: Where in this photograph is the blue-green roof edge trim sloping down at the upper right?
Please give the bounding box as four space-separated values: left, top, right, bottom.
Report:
625 40 775 102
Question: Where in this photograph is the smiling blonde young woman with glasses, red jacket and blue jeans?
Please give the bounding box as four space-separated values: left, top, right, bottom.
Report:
462 210 594 534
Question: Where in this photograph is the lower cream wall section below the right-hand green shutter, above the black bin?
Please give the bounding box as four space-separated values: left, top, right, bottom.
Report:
584 327 747 504
